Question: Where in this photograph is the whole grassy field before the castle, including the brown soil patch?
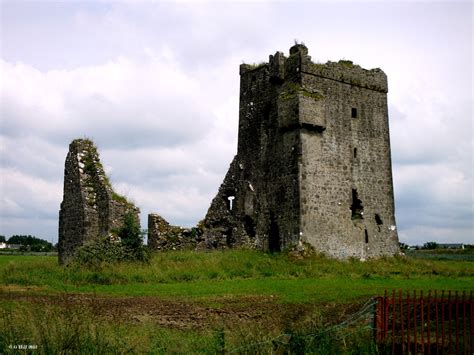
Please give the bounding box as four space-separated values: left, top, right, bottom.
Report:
0 250 474 353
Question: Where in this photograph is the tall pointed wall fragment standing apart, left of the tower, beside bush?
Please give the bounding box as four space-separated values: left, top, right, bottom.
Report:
58 139 139 264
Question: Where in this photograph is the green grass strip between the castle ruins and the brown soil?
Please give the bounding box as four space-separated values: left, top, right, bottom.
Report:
0 250 474 302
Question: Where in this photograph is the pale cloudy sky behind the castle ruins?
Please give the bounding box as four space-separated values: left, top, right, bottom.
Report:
0 0 474 244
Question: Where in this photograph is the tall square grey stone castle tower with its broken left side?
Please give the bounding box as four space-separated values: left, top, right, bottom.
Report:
203 44 399 258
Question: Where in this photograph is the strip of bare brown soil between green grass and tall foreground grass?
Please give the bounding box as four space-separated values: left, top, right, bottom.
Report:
0 288 361 330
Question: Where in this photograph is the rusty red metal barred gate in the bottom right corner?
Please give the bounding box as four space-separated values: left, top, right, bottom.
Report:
375 291 474 355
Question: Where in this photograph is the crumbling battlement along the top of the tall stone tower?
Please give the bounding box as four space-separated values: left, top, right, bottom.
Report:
240 44 388 93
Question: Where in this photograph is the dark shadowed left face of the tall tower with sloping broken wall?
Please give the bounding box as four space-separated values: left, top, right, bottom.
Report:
204 57 299 250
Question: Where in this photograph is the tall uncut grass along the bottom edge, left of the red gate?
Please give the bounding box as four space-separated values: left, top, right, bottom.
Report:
0 302 377 354
